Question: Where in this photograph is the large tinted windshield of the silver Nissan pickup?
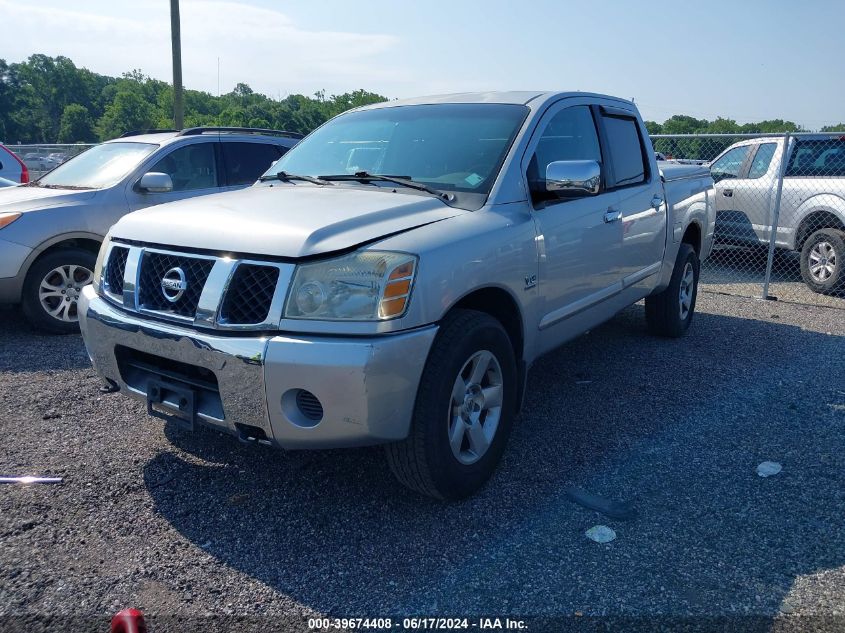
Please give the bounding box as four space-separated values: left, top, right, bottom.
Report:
267 103 528 194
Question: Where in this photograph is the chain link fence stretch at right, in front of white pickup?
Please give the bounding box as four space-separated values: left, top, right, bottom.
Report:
652 132 845 309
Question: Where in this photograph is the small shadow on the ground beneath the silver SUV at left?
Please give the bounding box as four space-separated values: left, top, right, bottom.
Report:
0 305 91 373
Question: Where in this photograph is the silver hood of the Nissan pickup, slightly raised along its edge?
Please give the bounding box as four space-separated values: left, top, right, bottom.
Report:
111 184 469 257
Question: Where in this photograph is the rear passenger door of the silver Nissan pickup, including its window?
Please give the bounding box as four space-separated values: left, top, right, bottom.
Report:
600 107 666 288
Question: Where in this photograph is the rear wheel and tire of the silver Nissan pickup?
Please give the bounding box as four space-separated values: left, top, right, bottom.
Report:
645 244 701 338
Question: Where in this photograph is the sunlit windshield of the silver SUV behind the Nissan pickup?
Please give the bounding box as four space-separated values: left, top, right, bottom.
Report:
36 142 158 189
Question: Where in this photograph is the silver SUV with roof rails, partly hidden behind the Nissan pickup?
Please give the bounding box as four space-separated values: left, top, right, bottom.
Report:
0 128 301 333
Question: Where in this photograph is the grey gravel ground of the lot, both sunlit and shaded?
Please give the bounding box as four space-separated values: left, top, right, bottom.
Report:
0 293 845 633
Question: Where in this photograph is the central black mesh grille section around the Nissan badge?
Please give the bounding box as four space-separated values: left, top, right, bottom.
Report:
138 251 214 318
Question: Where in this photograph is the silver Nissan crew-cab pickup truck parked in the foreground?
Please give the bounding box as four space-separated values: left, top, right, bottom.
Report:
79 92 715 499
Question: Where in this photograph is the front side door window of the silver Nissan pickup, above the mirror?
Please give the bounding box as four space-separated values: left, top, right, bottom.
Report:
528 106 601 191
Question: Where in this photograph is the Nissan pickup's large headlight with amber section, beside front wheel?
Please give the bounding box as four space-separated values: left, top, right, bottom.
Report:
285 251 417 321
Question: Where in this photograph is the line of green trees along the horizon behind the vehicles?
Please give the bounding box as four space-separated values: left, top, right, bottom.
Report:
0 54 845 146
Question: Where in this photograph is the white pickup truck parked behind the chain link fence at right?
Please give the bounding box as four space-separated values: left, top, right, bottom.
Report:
710 135 845 293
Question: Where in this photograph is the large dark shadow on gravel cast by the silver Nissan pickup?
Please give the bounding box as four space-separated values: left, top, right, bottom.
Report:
145 306 845 616
